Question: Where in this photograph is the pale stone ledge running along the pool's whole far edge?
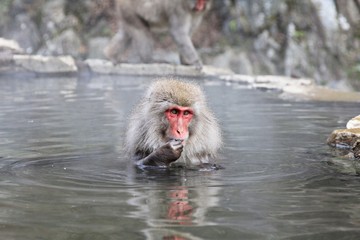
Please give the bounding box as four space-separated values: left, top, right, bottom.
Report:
0 54 360 102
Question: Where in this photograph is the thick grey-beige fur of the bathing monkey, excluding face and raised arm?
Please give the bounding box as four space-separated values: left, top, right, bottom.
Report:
126 79 222 167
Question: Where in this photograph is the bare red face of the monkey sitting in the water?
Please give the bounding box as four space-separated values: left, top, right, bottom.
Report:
165 106 194 140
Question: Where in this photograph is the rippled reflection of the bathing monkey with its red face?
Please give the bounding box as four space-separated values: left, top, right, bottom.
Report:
128 181 221 240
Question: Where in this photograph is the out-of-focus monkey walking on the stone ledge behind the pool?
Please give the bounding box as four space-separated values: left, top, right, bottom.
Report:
104 0 210 69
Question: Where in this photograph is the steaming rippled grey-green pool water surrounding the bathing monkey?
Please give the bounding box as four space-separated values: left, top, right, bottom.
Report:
0 74 360 240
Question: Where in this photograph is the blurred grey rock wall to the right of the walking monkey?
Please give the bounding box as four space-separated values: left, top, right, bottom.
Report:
200 0 360 89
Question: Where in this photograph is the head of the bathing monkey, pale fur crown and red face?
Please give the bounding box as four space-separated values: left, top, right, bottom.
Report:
146 80 206 144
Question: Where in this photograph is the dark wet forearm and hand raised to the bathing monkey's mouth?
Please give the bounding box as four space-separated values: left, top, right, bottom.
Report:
137 139 184 167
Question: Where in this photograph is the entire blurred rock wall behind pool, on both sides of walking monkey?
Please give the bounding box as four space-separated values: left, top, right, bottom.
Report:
0 0 360 89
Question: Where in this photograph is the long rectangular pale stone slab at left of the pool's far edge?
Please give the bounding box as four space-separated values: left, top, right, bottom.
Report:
13 55 77 74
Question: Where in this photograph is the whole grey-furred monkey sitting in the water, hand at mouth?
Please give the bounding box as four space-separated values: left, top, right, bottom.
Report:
126 79 222 169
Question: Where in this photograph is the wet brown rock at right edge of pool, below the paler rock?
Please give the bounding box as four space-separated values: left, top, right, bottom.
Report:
327 128 360 158
